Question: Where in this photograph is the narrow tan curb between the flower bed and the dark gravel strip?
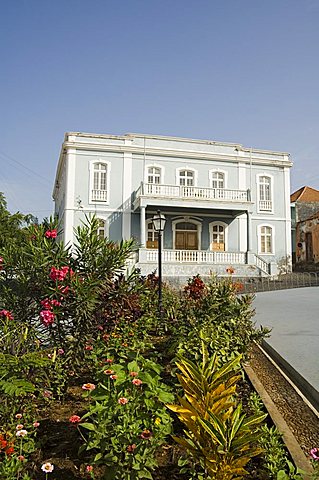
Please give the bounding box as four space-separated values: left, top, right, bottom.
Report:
244 365 313 480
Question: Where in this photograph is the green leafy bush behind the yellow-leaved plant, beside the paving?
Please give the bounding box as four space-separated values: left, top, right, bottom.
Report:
172 276 269 365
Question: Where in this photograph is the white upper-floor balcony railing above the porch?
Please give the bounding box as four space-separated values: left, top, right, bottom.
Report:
136 182 250 202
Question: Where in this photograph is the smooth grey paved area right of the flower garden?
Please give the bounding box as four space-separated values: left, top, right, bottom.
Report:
254 287 319 391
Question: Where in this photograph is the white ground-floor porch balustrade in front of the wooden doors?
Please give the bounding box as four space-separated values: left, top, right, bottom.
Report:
139 248 246 265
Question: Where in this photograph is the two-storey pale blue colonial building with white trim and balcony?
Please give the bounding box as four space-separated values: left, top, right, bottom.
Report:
53 132 292 278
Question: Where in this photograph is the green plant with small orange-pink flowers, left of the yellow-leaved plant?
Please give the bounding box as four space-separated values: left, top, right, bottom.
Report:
80 356 174 480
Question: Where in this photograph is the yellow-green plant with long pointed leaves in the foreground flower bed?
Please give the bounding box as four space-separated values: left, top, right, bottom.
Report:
167 344 267 480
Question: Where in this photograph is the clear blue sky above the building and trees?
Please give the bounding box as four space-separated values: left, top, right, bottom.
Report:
0 0 319 218
